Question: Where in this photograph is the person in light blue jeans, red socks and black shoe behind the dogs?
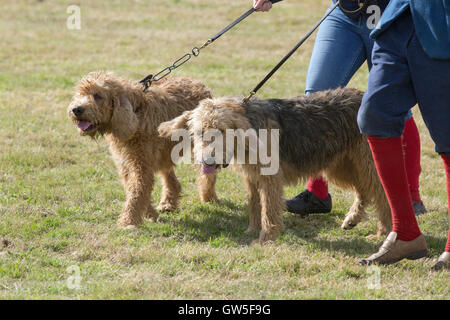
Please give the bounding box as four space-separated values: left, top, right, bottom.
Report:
253 0 426 215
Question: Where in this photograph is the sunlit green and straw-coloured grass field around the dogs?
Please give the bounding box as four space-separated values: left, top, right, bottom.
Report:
0 0 450 299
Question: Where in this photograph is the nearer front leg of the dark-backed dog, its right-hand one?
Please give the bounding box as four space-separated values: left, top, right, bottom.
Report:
258 175 284 243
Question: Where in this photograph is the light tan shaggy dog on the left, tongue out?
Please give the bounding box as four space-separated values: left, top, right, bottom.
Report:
68 72 217 228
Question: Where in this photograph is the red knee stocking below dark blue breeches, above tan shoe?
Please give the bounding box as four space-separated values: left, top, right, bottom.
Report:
367 136 421 241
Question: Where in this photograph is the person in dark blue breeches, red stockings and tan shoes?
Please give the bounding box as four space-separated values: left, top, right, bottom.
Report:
358 0 450 270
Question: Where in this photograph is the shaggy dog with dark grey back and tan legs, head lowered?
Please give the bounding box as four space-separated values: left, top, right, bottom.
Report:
159 89 391 242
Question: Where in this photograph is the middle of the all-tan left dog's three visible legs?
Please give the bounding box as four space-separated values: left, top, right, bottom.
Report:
156 167 181 211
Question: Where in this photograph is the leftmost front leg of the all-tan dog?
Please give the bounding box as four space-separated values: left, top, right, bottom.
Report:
117 167 158 228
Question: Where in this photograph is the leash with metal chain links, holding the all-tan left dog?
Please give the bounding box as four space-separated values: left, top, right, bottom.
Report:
139 0 282 91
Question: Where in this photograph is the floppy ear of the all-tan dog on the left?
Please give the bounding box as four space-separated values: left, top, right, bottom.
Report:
111 96 138 141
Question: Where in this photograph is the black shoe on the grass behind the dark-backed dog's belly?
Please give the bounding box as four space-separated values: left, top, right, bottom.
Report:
284 190 332 215
